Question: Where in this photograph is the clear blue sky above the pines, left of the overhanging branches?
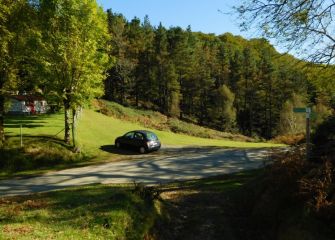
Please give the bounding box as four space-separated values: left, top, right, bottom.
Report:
98 0 247 38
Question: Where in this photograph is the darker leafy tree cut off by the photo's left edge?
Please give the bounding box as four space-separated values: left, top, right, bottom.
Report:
0 0 38 145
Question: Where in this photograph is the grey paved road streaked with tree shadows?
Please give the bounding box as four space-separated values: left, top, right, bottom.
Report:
0 147 276 197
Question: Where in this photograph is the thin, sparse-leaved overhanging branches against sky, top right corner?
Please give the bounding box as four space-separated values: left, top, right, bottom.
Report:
236 0 335 64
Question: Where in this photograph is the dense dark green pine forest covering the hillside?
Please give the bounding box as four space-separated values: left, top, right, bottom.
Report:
105 10 333 139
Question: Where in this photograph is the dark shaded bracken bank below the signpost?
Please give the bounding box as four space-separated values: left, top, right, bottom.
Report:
234 148 335 239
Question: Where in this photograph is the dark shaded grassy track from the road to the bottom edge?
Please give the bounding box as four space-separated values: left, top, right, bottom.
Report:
154 170 261 240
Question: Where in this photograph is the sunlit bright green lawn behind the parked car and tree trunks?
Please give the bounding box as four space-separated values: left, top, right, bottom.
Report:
6 109 280 156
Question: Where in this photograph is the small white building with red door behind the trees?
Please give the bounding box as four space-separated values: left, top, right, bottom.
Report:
7 95 49 115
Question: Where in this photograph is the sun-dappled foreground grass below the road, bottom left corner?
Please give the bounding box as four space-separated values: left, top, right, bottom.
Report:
0 185 156 240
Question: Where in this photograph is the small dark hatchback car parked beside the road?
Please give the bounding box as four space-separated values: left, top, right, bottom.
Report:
115 130 161 153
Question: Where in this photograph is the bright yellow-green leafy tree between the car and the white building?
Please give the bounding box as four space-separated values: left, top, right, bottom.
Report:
39 0 108 143
